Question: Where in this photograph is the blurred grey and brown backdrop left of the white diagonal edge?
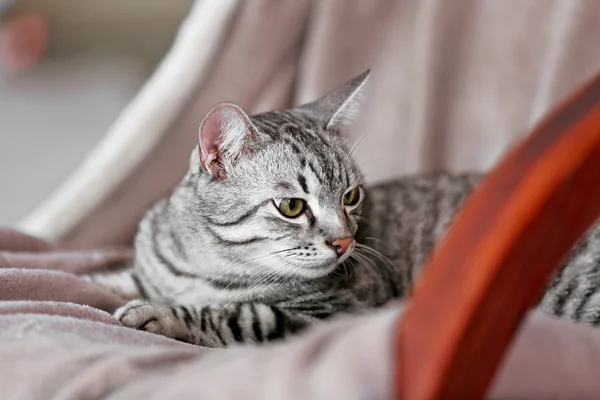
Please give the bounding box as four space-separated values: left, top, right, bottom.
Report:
0 0 193 225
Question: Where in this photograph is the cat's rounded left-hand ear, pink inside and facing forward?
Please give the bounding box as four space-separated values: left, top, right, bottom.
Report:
198 103 257 179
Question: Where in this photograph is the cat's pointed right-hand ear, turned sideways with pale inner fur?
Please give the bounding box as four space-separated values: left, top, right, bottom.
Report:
301 70 371 130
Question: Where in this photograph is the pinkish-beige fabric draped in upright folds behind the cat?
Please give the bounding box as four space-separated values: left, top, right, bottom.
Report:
21 0 600 247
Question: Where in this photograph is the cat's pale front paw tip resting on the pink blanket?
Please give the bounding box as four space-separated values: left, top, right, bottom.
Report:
115 300 188 340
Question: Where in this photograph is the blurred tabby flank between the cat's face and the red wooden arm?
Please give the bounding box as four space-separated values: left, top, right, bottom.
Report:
357 173 480 285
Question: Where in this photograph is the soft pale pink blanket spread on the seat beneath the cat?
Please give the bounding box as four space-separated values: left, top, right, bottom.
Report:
0 229 600 400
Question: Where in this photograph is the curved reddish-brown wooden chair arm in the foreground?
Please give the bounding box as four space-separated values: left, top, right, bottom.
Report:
396 72 600 400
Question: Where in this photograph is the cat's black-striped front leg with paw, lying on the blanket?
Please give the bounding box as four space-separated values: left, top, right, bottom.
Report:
115 300 317 347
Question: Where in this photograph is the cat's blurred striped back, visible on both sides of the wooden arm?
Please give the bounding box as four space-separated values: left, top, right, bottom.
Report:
357 173 600 324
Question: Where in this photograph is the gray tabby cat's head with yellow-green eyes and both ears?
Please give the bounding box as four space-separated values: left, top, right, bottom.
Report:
192 71 369 278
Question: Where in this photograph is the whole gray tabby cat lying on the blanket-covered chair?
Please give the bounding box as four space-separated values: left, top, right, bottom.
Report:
86 73 600 347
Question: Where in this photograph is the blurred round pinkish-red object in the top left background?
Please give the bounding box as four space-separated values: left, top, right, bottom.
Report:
0 14 48 74
